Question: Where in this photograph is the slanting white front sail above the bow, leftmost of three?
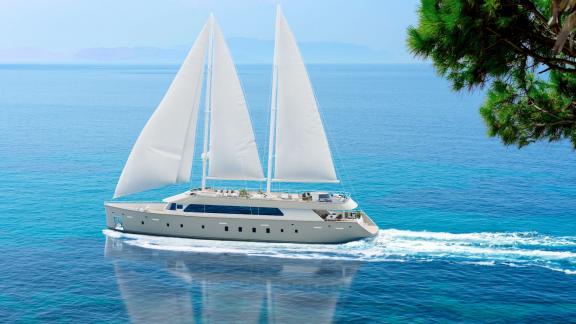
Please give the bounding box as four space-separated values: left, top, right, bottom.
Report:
114 18 212 198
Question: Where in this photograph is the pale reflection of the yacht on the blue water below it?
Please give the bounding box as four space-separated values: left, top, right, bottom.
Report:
105 237 360 323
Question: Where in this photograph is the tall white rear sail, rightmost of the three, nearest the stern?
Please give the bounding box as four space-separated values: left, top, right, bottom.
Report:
272 7 338 182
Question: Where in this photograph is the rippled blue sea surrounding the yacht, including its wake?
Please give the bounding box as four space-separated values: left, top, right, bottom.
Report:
0 65 576 323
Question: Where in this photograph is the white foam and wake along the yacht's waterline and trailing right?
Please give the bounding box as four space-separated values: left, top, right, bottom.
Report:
104 229 576 274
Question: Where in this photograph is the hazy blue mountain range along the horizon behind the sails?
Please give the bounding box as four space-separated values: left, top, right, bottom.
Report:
0 38 411 64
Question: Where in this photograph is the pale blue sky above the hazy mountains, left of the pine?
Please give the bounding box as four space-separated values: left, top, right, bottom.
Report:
0 0 419 61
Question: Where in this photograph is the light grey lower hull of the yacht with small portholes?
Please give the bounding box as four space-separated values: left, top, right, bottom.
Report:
105 203 378 244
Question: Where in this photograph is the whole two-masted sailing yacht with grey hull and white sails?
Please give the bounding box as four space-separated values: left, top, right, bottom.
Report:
104 8 378 243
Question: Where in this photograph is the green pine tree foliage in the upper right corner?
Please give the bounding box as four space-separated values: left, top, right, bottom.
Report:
408 0 576 149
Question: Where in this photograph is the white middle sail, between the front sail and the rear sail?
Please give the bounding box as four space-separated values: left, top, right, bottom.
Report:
208 22 264 180
